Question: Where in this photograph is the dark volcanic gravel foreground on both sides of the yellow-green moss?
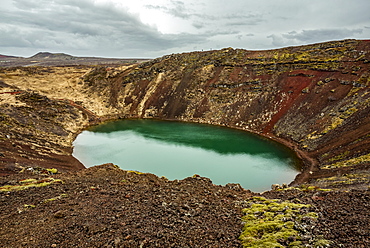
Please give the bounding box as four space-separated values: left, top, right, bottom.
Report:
0 164 370 247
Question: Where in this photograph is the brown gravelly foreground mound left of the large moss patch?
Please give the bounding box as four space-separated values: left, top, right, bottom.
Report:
0 165 250 247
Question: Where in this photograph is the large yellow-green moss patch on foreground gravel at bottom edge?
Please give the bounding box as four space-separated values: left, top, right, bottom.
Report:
239 197 328 247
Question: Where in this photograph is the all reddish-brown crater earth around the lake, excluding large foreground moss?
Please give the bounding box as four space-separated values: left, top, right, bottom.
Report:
0 40 370 247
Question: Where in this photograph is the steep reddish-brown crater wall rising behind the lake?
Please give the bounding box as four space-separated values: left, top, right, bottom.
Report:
0 40 370 188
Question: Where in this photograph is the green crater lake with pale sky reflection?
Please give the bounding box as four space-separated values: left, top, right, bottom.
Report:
73 120 299 192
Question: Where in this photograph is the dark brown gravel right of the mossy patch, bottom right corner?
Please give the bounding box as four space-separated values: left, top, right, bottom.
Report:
264 190 370 247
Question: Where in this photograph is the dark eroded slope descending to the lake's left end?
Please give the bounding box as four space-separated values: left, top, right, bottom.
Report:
0 89 86 174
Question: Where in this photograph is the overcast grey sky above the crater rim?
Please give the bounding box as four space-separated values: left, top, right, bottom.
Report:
0 0 370 58
